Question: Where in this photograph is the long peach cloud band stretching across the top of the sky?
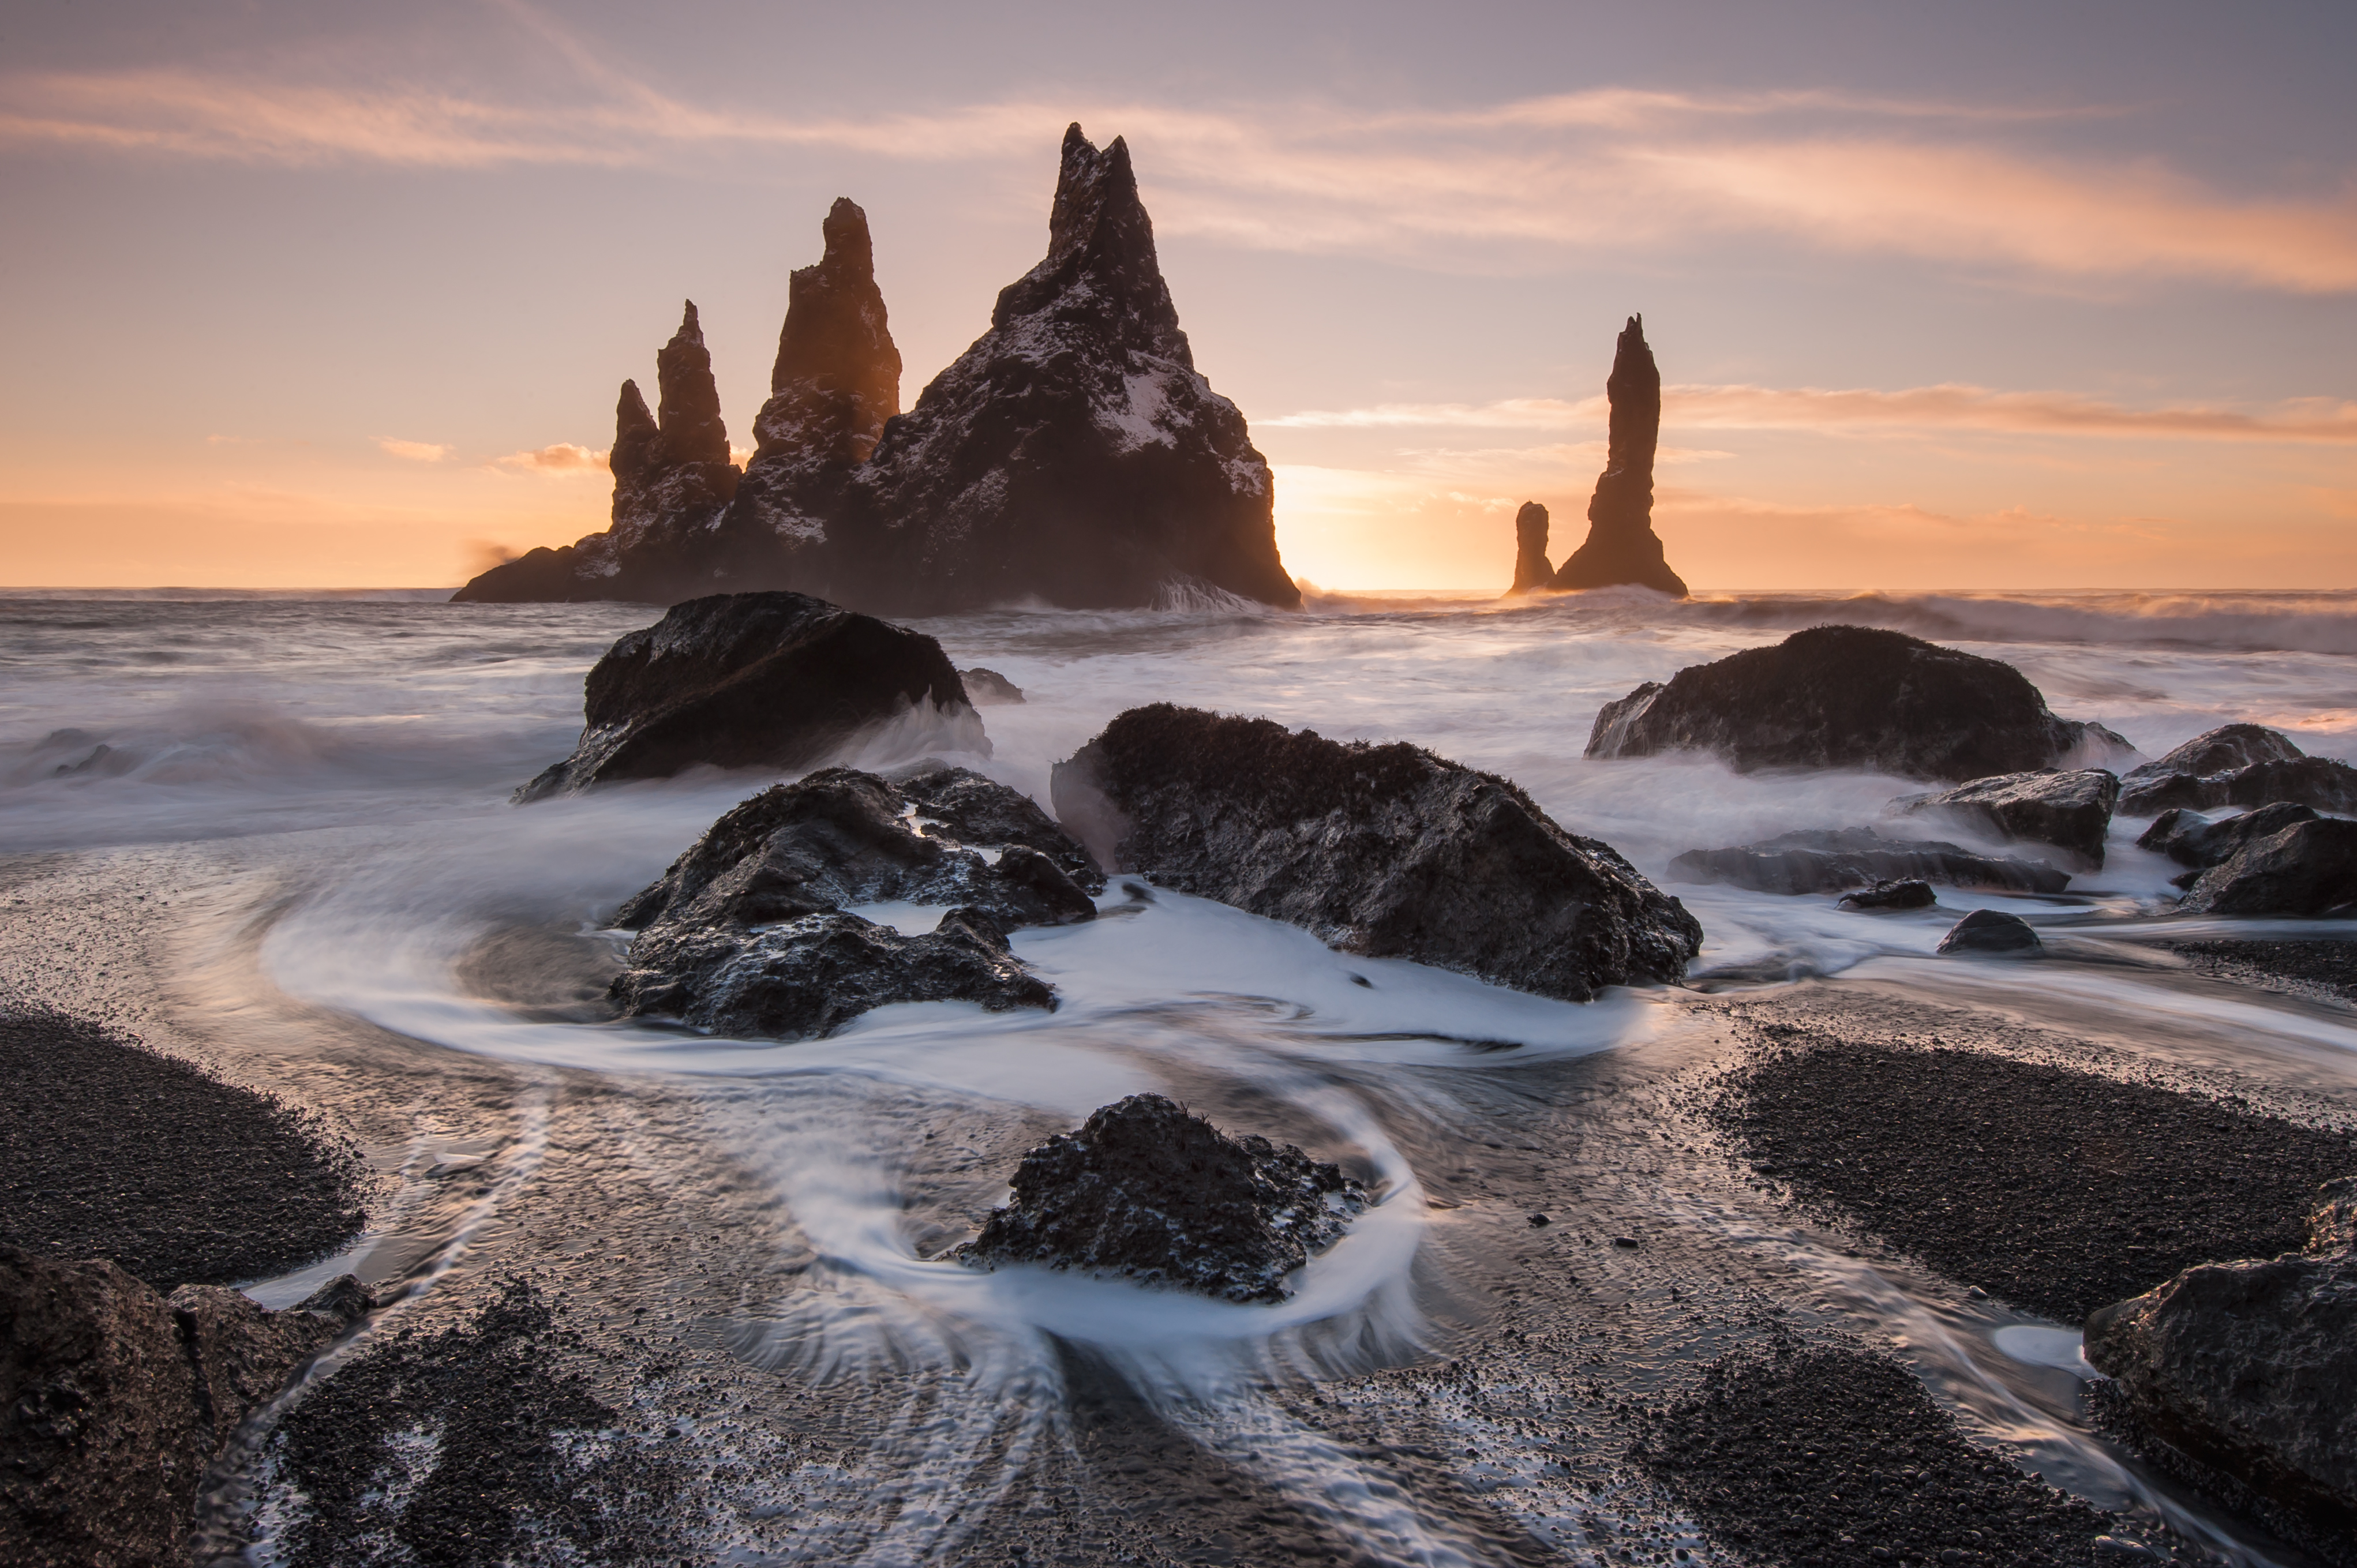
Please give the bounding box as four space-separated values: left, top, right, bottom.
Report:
0 19 2357 292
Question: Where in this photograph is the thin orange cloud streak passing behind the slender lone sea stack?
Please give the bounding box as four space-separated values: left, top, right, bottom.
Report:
1256 382 2357 445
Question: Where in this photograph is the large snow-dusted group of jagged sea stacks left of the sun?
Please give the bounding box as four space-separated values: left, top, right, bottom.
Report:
457 125 1301 616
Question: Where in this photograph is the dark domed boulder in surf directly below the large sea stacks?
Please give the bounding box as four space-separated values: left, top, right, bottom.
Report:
516 594 988 802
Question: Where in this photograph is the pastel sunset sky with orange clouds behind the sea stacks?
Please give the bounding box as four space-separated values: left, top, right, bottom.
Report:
0 0 2357 590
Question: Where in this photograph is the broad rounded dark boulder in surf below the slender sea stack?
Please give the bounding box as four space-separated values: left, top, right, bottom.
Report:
1586 627 2131 783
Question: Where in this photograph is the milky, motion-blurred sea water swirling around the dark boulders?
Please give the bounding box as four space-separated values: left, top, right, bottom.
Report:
0 590 2357 1563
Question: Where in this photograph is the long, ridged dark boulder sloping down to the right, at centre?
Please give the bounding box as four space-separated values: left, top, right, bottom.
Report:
1051 703 1702 1002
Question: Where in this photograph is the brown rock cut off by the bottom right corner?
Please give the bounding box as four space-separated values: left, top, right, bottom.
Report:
2086 1179 2357 1563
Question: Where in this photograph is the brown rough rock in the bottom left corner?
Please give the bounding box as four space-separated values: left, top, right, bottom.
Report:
0 1245 370 1568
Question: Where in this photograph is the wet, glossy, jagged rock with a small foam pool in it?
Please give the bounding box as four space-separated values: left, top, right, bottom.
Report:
610 768 1103 1040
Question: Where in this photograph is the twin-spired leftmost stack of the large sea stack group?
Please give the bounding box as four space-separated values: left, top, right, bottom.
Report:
452 299 738 603
